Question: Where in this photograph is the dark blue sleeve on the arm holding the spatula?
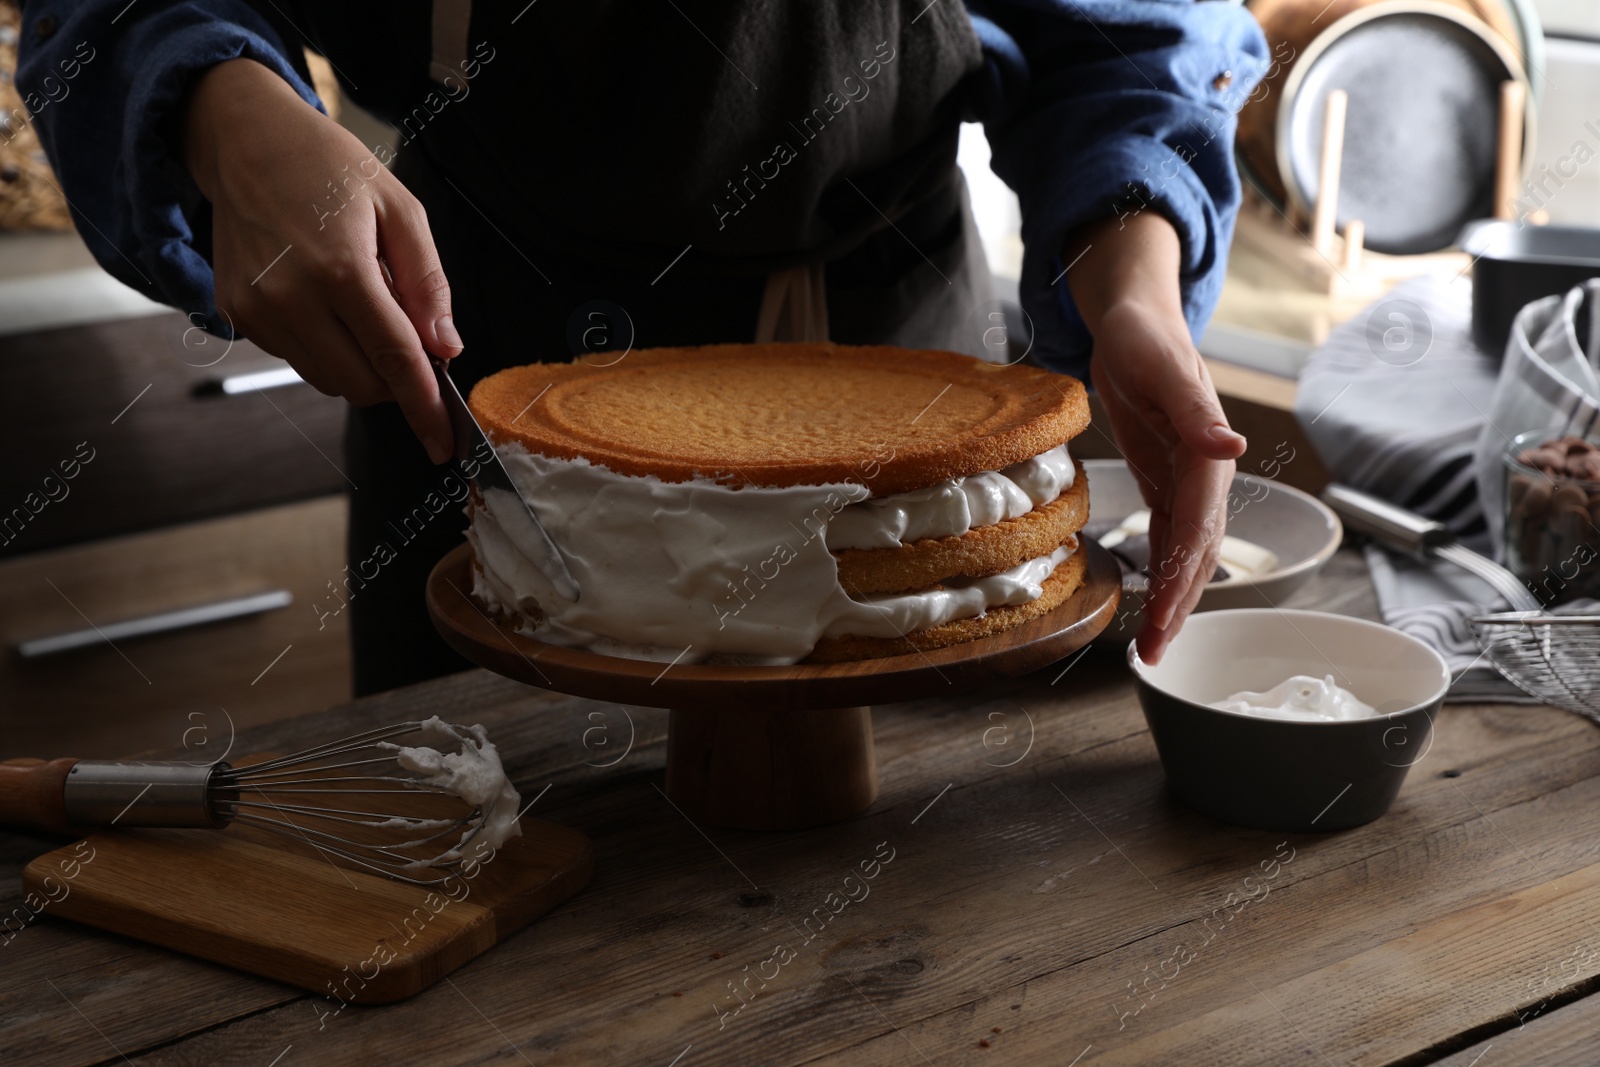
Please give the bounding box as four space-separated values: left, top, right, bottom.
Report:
16 0 322 336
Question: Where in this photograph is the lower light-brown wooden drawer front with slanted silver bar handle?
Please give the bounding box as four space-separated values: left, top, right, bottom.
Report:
0 499 350 761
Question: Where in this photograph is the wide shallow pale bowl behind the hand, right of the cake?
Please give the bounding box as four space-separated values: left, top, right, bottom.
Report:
1083 459 1344 645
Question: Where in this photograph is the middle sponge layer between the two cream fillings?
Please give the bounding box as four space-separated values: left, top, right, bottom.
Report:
834 467 1090 597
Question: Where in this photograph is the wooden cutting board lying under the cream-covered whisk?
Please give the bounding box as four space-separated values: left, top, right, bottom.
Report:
22 777 594 1011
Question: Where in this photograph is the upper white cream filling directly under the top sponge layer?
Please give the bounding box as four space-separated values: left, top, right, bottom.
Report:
827 445 1075 552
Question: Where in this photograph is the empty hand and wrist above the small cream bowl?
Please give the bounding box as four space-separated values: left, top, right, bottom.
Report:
1064 211 1245 664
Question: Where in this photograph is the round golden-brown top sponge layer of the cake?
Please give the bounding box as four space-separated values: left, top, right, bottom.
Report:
469 344 1090 496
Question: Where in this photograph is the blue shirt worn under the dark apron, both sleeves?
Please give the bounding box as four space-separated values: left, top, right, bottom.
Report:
16 0 1267 378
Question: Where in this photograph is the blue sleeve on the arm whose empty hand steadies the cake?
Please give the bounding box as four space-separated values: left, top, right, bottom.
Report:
966 0 1267 378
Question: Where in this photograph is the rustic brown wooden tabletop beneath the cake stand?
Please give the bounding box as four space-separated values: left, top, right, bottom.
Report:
0 550 1600 1067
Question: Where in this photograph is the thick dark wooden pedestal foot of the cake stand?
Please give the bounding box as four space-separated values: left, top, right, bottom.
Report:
667 707 878 830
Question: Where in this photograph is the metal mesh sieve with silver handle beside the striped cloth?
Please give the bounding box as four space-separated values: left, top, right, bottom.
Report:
1322 485 1600 723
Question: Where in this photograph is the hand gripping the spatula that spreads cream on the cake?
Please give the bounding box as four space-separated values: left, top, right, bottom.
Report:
184 59 461 462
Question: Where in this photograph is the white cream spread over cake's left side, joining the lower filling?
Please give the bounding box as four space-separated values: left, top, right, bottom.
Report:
467 443 1070 664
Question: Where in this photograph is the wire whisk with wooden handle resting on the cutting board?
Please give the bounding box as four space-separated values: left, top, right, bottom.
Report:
0 720 512 886
